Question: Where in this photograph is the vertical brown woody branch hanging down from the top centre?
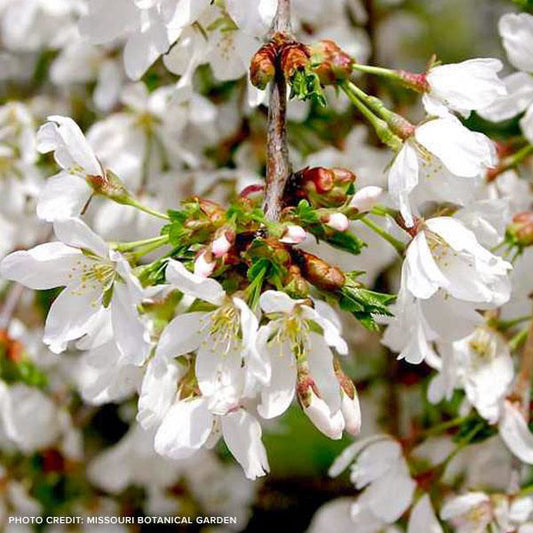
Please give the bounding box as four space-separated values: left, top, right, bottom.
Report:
263 0 292 220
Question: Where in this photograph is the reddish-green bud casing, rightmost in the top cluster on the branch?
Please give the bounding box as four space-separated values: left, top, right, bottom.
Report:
309 40 354 85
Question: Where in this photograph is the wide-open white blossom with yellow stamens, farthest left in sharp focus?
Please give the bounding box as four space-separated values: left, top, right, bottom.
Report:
0 218 150 364
